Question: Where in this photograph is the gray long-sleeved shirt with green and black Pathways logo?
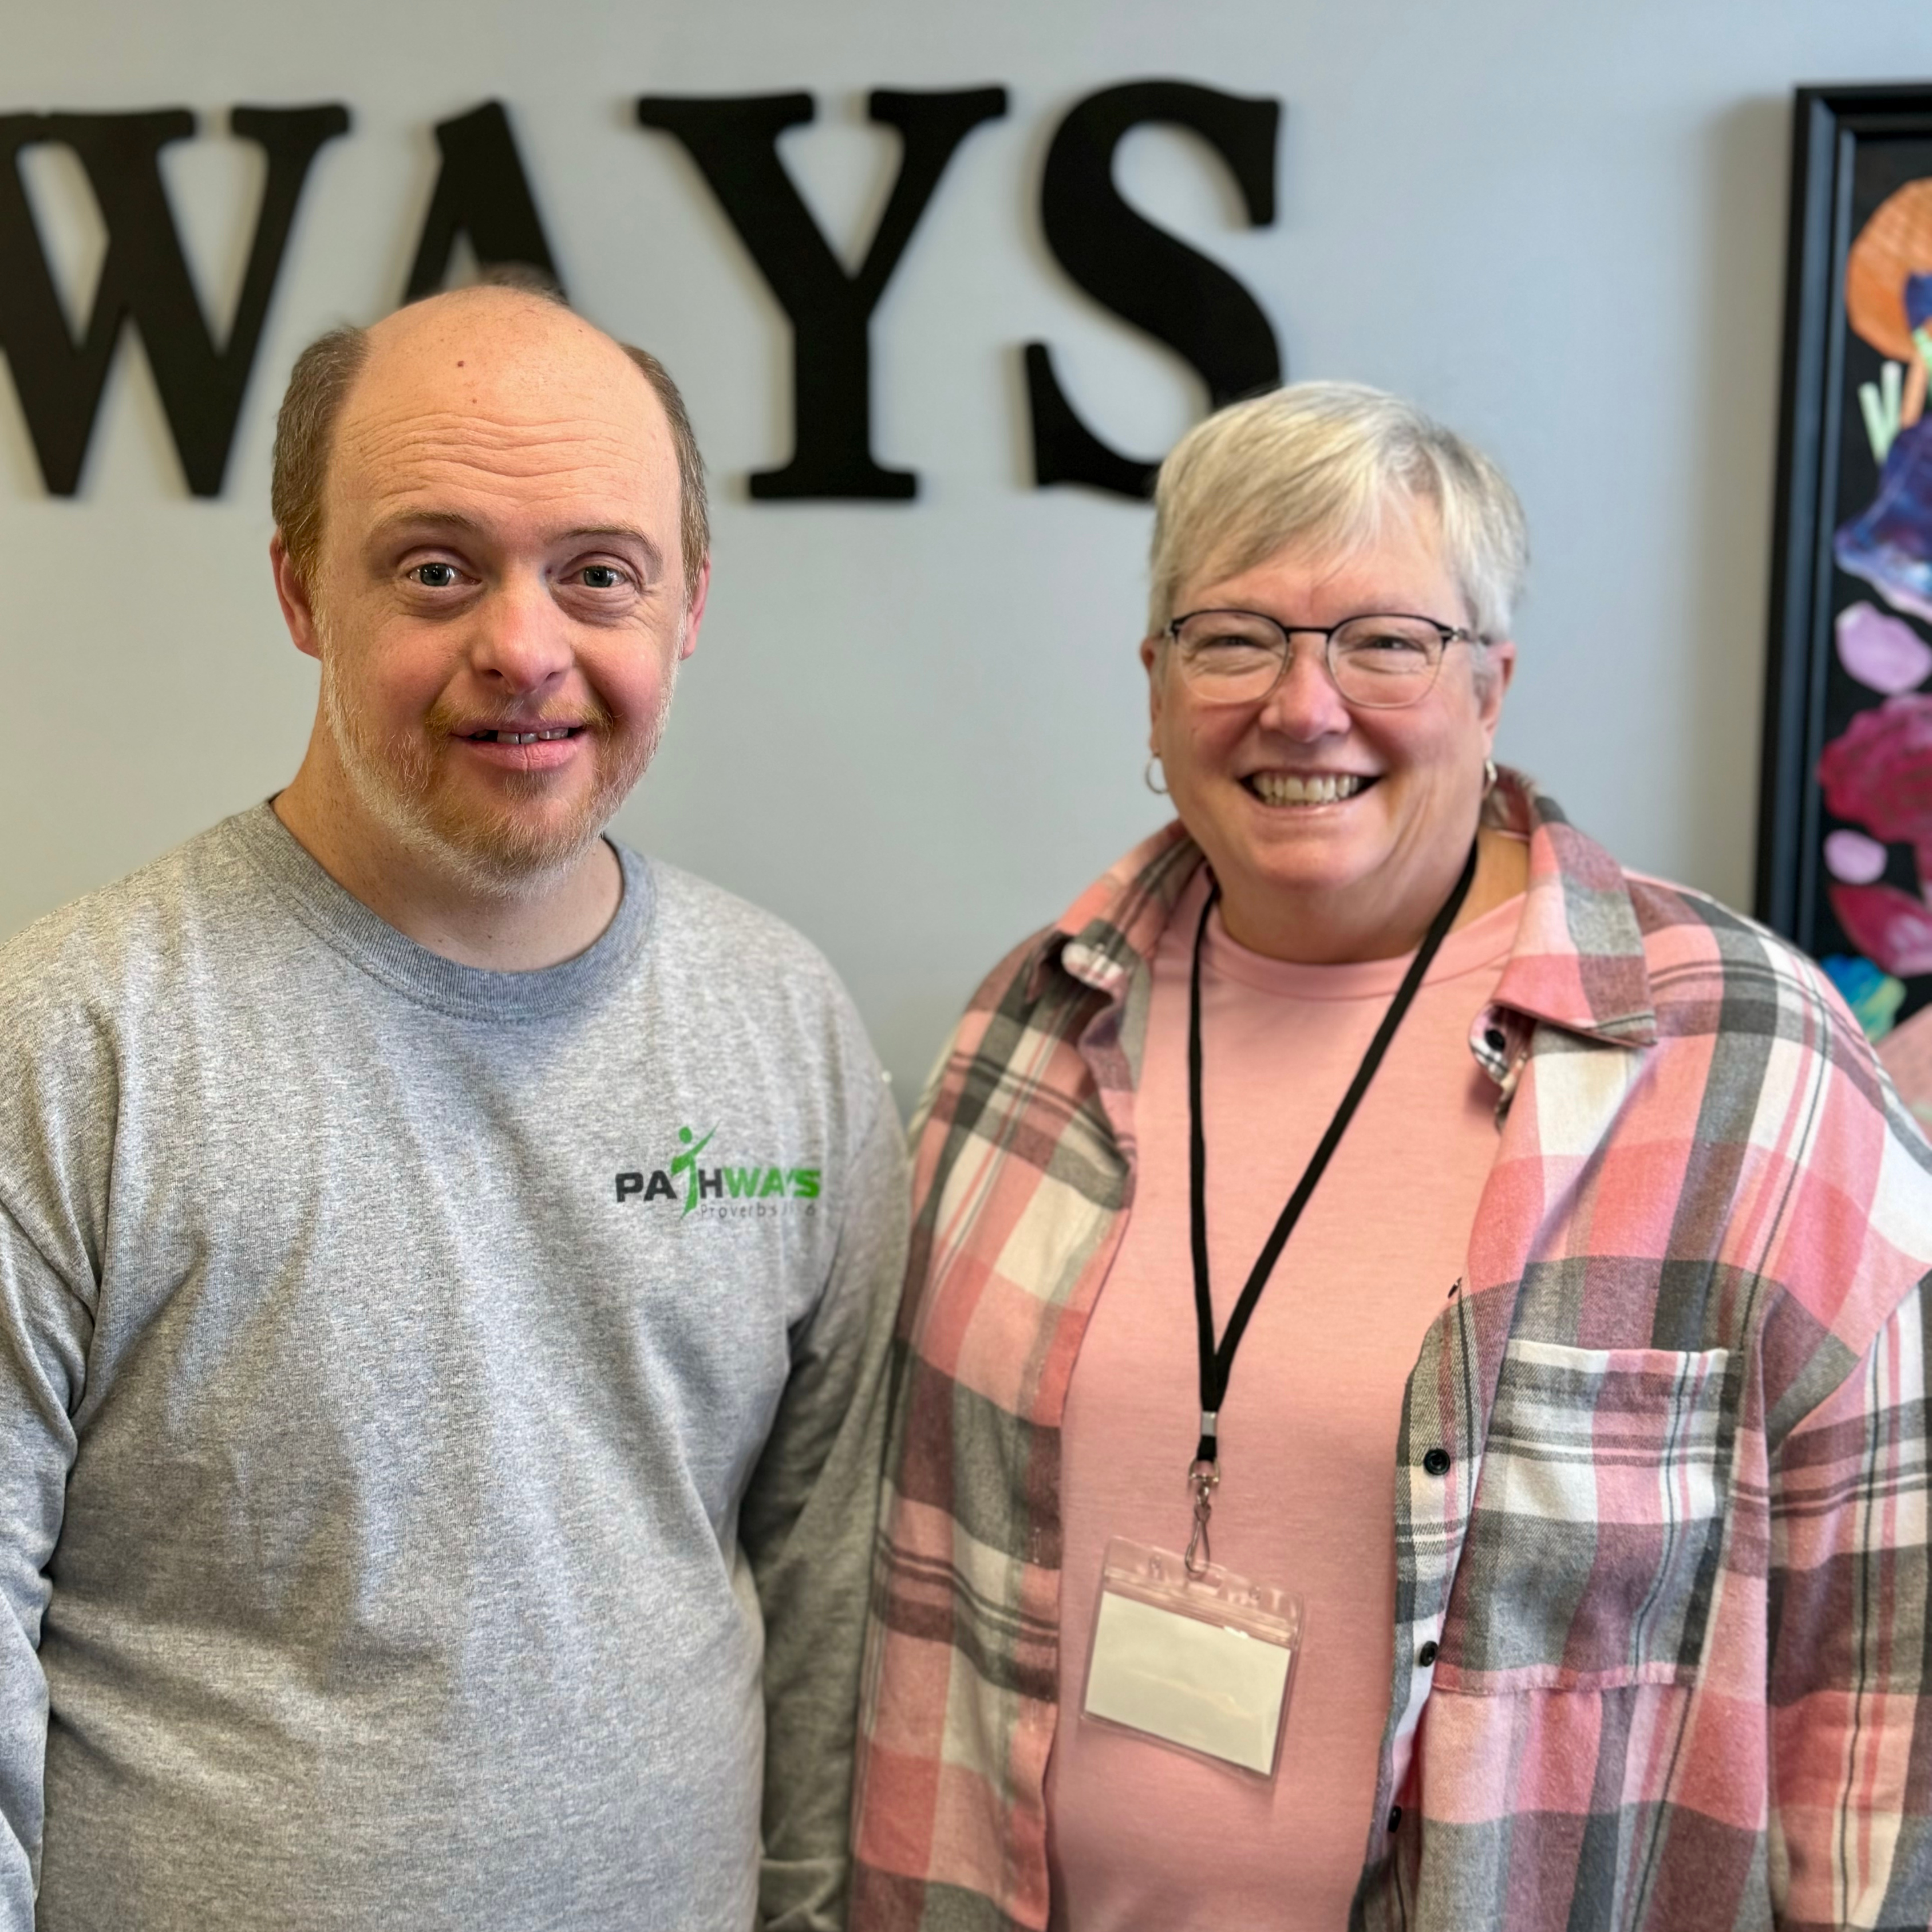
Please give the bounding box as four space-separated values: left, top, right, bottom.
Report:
0 805 904 1932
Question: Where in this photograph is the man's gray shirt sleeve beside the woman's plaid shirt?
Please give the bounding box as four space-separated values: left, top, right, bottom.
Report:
740 1082 906 1932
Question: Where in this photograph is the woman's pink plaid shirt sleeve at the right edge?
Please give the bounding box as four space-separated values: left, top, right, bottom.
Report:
1766 1277 1932 1932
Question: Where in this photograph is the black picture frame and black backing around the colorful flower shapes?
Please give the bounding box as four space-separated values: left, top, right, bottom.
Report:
1756 81 1932 1034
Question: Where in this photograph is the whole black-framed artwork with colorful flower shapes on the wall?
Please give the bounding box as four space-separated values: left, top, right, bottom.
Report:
1758 81 1932 1099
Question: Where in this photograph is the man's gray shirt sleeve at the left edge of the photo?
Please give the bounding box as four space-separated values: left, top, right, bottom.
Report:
0 1206 93 1932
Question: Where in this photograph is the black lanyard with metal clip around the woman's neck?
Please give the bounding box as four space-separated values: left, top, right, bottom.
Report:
1188 844 1476 1476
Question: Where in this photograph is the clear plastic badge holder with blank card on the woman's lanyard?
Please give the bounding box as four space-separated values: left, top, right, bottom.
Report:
1080 1536 1302 1781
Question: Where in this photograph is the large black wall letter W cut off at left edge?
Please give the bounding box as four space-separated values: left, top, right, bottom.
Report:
0 106 350 496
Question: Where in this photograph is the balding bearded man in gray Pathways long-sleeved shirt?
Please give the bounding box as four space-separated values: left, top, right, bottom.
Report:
0 288 904 1932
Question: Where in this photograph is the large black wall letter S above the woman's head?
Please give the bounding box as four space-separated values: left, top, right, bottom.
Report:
1026 81 1281 496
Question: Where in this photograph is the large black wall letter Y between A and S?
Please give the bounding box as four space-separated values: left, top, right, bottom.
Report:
638 87 1006 499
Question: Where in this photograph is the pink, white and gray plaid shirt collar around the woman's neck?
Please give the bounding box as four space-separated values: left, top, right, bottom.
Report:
1030 767 1658 1047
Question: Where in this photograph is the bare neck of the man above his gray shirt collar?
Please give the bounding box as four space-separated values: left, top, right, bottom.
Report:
272 757 624 972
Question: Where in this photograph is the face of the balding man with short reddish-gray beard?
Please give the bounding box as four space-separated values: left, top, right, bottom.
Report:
290 292 704 892
